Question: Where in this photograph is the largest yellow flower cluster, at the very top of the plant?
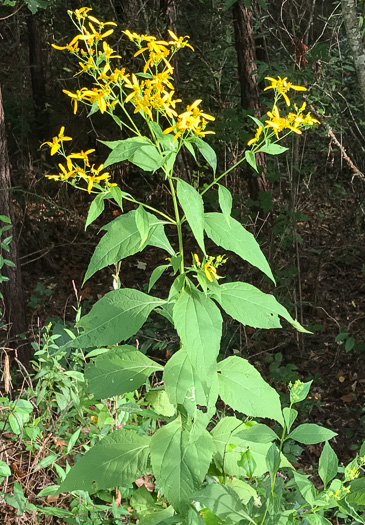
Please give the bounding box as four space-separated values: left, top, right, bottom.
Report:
52 7 215 141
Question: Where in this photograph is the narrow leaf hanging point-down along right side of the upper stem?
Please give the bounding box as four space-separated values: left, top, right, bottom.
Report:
177 179 205 255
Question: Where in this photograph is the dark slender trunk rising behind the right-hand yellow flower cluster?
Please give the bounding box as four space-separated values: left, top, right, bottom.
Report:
232 0 268 201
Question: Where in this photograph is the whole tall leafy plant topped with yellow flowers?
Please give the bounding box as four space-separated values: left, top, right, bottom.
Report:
38 7 362 525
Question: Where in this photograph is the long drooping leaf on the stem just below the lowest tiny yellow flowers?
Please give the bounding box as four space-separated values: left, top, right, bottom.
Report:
173 288 222 373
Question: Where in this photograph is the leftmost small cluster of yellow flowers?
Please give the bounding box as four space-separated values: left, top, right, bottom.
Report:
41 126 112 193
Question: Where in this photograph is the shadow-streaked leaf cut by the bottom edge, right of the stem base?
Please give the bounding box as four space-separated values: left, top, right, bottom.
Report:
193 483 255 525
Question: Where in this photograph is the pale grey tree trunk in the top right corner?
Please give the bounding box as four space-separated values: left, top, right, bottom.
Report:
341 0 365 112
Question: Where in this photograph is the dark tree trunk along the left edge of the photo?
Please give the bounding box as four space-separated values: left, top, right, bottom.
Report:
0 86 31 367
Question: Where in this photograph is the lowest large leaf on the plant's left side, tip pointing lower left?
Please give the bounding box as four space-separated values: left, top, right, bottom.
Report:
58 429 151 493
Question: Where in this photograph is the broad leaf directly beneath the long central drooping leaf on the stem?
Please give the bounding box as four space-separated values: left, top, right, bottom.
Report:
163 348 218 417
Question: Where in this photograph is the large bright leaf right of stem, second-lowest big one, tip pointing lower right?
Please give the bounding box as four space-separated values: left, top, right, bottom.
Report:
218 356 284 425
